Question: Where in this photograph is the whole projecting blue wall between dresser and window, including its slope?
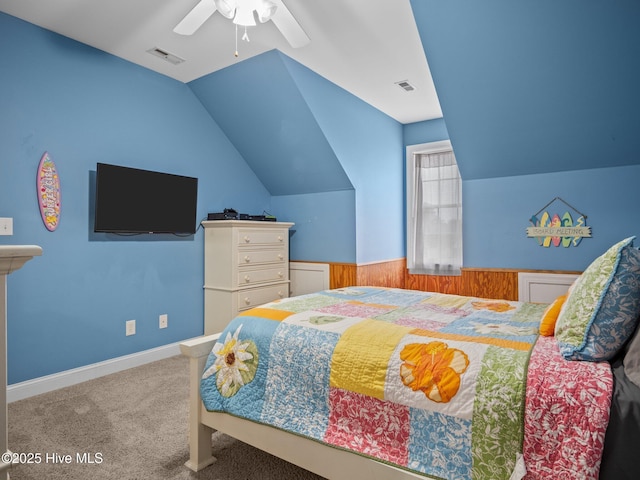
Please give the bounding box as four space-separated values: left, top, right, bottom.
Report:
189 50 404 263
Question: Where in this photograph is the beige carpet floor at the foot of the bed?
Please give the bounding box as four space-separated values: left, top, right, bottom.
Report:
8 356 321 480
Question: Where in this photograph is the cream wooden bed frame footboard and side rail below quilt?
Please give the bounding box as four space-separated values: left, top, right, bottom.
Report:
180 334 425 480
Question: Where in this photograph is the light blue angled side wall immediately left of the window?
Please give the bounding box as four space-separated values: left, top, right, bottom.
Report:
276 58 405 264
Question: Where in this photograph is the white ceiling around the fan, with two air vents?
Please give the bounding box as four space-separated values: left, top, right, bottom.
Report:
0 0 442 123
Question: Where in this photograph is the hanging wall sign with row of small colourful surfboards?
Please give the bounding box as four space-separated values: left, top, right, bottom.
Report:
527 197 591 248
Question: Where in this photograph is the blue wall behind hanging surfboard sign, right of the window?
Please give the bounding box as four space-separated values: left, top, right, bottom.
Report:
462 165 640 271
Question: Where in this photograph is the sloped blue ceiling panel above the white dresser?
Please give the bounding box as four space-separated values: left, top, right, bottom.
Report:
189 50 353 195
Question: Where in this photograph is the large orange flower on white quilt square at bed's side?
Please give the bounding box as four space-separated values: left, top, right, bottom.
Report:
400 341 469 403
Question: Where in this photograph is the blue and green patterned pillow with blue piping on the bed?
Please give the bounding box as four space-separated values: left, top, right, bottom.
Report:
555 237 640 362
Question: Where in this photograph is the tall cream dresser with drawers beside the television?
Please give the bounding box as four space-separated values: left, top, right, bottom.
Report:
202 220 293 335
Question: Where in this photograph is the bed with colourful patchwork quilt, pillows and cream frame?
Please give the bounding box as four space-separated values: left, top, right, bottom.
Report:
181 238 640 480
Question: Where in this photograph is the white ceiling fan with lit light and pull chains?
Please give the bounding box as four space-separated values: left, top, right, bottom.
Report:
173 0 311 48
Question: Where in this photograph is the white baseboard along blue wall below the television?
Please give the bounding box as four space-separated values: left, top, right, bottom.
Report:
7 343 180 403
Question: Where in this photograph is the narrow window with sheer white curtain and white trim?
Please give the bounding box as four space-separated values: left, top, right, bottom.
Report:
407 140 462 275
